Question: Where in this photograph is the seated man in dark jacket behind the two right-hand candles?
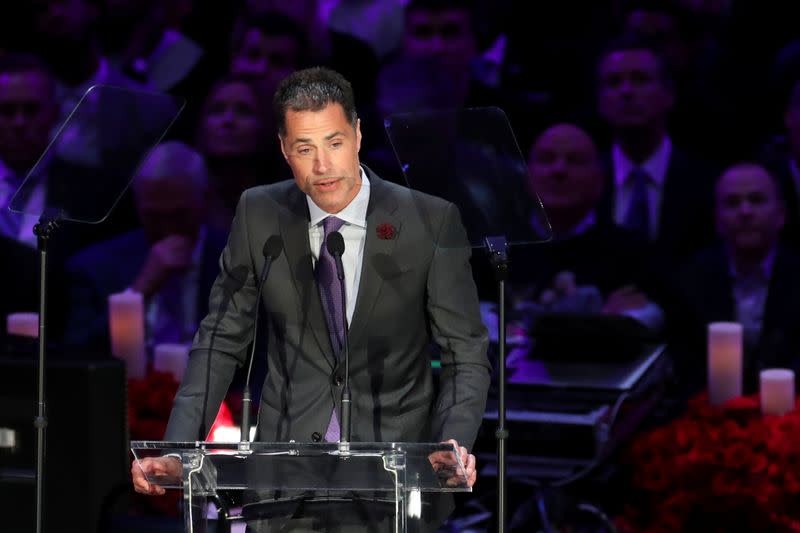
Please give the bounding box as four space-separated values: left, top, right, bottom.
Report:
670 163 800 396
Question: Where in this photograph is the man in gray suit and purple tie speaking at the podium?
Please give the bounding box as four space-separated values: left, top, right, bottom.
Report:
132 68 491 524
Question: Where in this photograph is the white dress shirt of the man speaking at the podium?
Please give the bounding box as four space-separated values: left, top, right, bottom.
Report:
306 168 369 325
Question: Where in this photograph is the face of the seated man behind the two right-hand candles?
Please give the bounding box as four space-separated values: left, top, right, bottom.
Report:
715 165 785 252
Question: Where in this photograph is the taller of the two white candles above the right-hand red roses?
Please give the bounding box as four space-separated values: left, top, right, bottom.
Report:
708 322 742 405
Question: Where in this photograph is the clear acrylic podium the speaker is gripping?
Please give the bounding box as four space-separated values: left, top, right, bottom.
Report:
131 441 472 533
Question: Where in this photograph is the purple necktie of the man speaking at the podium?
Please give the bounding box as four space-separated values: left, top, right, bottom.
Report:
316 217 346 442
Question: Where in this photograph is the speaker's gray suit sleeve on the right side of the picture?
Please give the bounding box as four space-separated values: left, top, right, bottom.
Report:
427 204 491 449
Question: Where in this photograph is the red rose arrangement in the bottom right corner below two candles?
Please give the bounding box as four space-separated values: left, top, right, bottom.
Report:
617 394 800 532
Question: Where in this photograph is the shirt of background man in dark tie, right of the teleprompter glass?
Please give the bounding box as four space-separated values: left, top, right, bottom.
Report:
611 136 672 239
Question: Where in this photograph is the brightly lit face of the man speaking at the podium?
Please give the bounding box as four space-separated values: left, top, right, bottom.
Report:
280 104 361 214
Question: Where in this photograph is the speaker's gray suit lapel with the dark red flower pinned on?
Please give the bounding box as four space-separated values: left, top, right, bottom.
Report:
349 176 402 346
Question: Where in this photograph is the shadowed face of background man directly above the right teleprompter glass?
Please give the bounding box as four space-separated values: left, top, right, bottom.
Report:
403 9 476 75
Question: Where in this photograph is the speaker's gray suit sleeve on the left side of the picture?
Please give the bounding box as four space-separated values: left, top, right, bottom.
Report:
164 192 256 441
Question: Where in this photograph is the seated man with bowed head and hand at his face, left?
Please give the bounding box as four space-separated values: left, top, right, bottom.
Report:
65 141 226 352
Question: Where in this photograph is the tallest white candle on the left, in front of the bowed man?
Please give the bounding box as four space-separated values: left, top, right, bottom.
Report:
108 291 147 378
